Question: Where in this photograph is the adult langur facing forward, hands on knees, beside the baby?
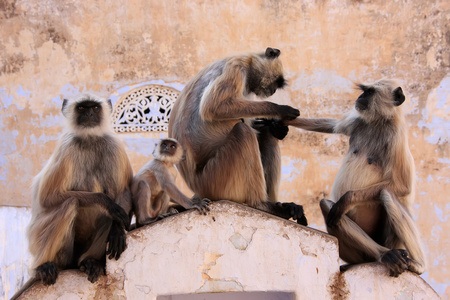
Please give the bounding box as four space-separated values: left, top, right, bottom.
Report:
28 94 133 285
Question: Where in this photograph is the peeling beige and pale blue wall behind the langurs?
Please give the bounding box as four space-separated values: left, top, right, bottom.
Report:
0 0 450 299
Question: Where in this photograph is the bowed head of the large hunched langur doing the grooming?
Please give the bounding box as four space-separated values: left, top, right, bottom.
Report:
247 48 286 98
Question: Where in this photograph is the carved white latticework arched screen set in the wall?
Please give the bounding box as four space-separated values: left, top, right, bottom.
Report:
113 84 180 132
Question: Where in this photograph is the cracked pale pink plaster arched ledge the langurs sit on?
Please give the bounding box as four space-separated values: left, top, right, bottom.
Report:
14 201 439 300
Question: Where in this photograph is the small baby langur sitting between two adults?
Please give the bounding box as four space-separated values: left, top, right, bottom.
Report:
131 139 210 227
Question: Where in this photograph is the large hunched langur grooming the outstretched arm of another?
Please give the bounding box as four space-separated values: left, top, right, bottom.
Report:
169 48 307 225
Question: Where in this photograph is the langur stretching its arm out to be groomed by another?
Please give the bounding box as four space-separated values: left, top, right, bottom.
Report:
285 80 425 277
